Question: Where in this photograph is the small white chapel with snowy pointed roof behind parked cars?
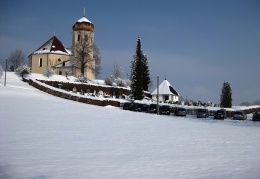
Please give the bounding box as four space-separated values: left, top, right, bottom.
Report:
151 79 180 102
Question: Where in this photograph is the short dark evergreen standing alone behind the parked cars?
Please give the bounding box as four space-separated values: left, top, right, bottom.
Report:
220 82 232 108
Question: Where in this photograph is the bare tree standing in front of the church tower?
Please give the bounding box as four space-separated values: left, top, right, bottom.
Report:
71 34 95 76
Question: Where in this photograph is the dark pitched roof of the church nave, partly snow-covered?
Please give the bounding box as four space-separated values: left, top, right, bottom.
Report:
33 36 71 55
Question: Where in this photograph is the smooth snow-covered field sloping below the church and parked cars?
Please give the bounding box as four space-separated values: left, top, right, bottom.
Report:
0 74 260 179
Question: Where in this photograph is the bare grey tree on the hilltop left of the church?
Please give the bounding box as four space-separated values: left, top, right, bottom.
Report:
8 49 25 71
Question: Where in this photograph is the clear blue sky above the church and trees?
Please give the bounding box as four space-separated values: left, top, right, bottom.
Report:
0 0 260 105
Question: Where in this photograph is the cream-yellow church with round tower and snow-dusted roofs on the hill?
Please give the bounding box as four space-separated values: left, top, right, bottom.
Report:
28 11 95 79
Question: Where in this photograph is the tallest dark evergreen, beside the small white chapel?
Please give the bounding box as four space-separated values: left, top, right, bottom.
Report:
130 37 151 100
